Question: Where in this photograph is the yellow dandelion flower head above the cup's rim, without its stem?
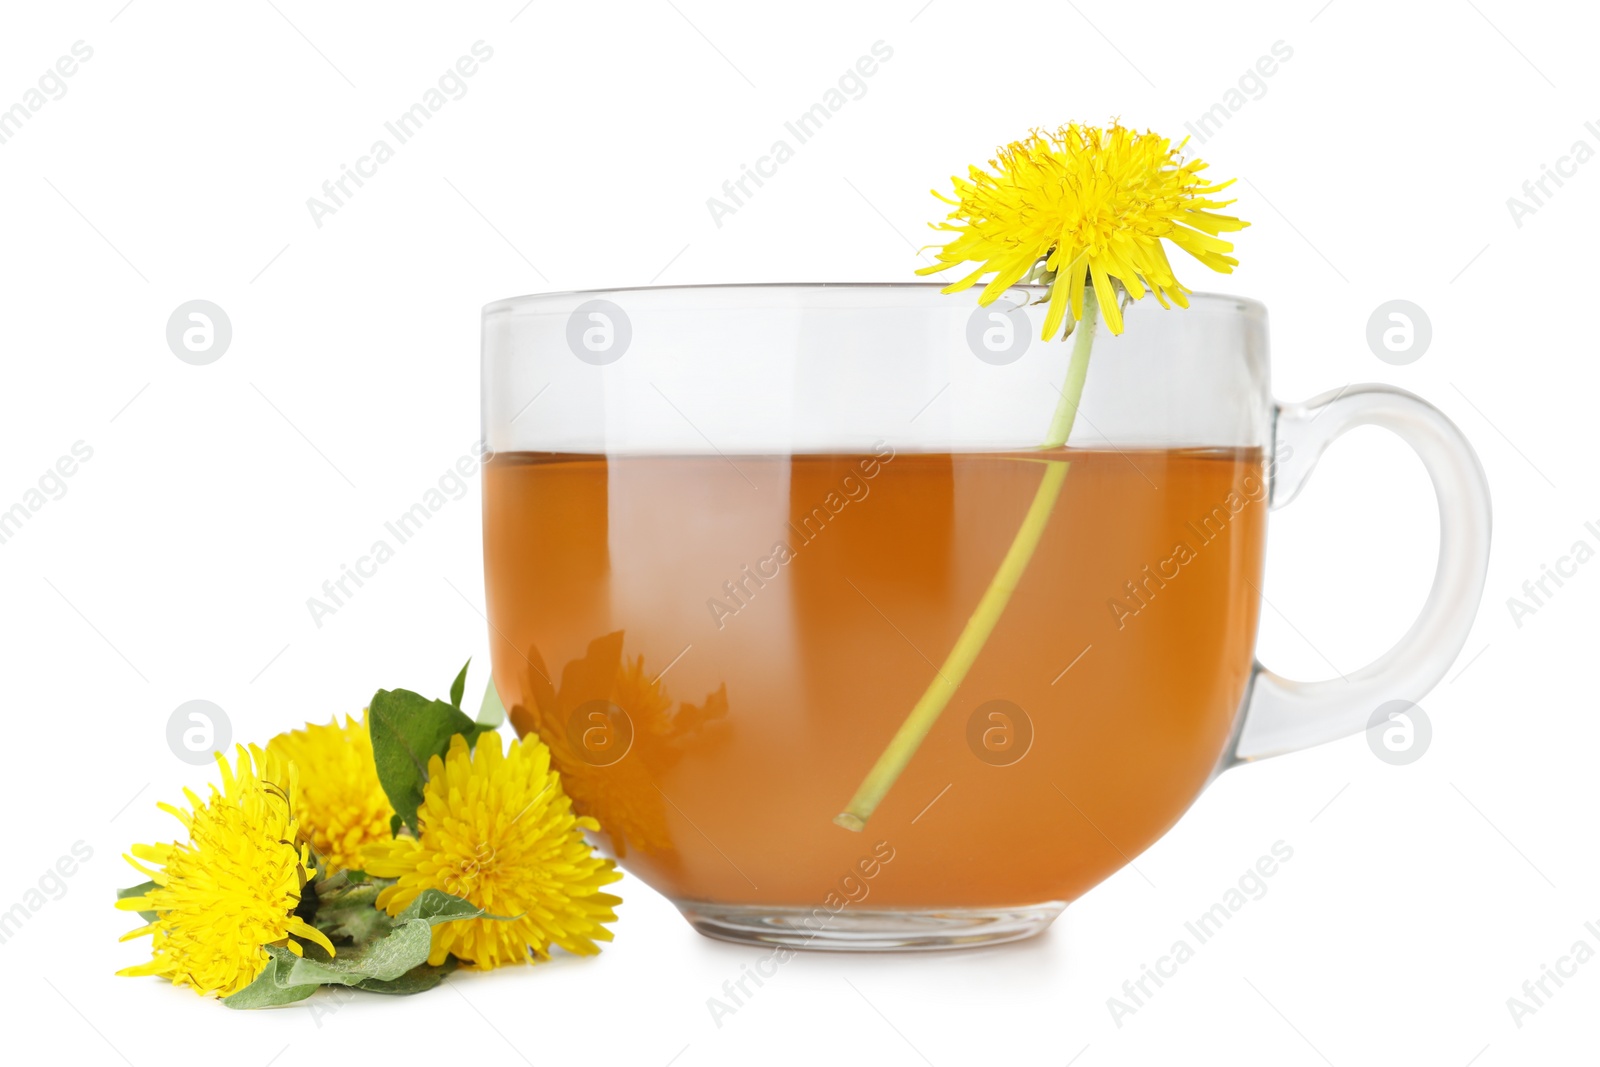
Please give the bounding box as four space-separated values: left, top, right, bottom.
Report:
917 123 1250 341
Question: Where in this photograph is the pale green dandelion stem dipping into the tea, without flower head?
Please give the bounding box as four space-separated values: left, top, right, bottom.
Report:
834 293 1099 833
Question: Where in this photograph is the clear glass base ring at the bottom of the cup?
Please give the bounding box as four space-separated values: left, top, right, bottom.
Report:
678 901 1067 952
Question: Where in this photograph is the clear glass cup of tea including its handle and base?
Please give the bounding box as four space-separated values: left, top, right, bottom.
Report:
470 285 1490 949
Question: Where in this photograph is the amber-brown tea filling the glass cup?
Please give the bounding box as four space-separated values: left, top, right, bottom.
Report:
485 448 1267 907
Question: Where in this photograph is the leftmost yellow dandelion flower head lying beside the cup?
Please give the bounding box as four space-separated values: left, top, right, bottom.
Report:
117 745 333 997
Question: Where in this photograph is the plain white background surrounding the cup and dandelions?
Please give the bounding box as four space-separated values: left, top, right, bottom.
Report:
0 0 1600 1067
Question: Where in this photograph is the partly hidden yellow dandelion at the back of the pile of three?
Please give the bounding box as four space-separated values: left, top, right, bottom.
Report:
267 715 394 870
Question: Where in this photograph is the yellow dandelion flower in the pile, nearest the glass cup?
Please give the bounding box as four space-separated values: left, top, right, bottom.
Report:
362 733 622 968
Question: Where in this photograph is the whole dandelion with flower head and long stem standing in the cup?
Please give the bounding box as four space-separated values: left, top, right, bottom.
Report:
834 122 1250 833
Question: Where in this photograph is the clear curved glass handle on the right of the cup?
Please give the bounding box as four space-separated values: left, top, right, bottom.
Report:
1226 386 1490 766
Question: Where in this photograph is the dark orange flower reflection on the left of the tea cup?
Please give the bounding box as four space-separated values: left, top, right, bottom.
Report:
509 630 728 856
